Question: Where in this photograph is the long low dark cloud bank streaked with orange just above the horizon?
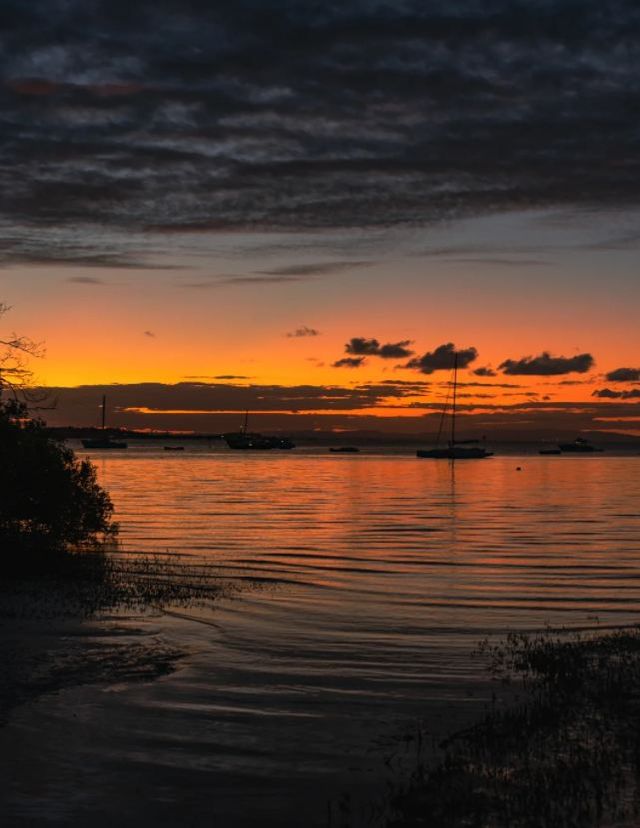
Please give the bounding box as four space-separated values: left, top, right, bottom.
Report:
33 380 640 440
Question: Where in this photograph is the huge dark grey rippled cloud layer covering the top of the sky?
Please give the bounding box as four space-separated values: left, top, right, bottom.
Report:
0 0 640 257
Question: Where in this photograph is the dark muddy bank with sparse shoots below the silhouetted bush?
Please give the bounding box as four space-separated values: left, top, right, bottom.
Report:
0 545 237 725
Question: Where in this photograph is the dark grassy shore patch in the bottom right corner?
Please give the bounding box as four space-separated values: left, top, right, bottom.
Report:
388 627 640 828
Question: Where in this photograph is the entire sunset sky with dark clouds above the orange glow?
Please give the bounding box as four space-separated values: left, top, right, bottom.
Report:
0 0 640 437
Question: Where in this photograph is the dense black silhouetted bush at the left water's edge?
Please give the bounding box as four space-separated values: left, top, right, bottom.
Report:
0 401 117 571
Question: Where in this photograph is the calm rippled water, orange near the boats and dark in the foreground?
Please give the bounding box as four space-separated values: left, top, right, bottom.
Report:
0 446 640 828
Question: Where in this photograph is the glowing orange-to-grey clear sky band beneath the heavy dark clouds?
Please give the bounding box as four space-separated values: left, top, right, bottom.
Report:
0 212 640 434
